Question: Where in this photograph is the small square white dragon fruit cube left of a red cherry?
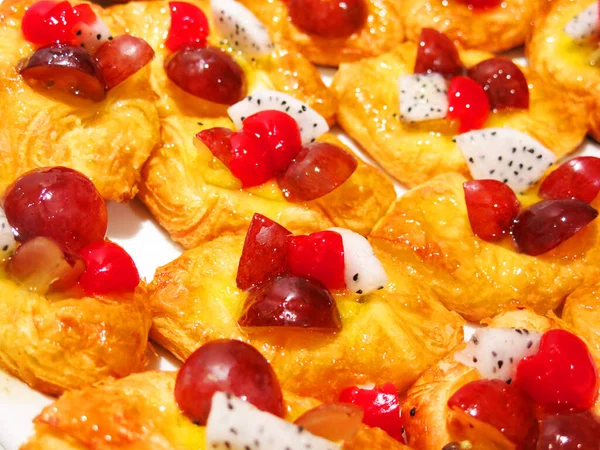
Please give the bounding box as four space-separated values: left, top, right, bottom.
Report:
398 73 448 122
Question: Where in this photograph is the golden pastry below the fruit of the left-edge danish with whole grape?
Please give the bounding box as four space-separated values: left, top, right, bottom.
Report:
0 275 151 395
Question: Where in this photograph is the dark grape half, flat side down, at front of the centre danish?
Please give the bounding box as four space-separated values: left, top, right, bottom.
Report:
238 276 342 331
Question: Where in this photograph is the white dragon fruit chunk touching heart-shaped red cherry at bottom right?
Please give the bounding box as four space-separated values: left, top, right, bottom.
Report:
454 328 542 383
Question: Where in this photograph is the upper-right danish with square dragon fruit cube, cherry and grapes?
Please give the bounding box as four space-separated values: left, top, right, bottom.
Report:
333 29 586 186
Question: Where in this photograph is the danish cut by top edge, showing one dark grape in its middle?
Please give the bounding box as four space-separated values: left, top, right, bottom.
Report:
239 0 404 66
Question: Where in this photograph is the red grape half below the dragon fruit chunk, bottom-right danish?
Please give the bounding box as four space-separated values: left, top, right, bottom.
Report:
448 380 537 450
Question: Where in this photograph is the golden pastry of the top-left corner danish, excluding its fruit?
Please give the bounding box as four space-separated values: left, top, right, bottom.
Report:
0 0 160 201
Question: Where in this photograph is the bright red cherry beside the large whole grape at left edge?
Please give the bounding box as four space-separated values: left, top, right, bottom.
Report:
79 241 140 295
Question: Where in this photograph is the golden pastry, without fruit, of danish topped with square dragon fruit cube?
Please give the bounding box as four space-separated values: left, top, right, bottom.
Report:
333 43 586 187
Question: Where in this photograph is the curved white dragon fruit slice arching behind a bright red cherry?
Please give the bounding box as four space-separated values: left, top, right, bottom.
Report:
227 90 329 144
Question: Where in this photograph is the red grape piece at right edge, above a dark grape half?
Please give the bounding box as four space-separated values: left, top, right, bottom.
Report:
540 156 600 203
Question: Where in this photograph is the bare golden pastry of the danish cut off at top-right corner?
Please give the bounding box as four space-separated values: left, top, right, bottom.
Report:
525 0 600 140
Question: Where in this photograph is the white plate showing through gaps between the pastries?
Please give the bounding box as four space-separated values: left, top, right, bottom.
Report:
0 60 600 450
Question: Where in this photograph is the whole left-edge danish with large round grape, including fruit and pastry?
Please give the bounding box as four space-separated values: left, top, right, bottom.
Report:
0 167 151 395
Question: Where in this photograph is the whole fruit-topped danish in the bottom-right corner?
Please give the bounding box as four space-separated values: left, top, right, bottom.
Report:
402 310 600 450
